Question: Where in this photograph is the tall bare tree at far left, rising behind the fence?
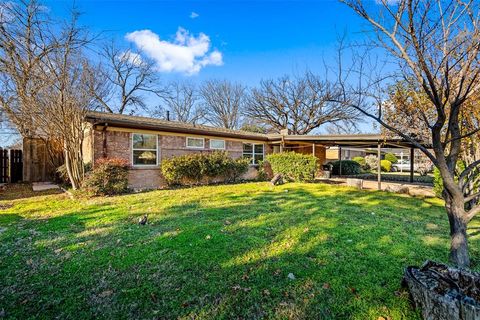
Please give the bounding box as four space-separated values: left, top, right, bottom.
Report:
0 0 60 137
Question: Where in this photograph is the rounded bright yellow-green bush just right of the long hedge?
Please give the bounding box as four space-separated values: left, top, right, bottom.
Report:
266 152 317 181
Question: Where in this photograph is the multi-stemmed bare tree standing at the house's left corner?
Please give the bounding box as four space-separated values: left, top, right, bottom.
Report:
38 55 95 189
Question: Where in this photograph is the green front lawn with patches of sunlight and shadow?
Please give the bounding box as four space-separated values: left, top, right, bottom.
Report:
0 183 479 320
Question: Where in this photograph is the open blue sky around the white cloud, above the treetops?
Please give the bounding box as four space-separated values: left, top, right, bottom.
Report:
46 0 365 85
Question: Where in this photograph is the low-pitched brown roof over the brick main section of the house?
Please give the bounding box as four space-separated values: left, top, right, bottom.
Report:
86 111 268 141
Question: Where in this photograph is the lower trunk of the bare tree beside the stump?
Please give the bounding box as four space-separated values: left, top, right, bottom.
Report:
445 195 470 268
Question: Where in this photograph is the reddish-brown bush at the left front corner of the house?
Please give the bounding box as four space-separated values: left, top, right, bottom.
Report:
83 158 129 196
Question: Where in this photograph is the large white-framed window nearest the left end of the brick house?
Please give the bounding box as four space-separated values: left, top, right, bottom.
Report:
132 133 158 166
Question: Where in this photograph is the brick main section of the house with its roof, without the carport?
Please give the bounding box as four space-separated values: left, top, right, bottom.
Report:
83 112 280 189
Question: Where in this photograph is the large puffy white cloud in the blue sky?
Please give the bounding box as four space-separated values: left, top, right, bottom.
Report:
125 28 223 74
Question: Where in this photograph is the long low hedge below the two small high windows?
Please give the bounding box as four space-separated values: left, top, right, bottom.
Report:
161 151 249 186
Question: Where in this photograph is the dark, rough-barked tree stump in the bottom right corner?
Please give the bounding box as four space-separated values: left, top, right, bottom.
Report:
404 261 480 320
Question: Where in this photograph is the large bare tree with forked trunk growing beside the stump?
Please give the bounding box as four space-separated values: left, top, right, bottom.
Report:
341 0 480 267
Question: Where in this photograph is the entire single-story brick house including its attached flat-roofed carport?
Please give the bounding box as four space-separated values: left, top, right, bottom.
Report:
83 112 428 189
